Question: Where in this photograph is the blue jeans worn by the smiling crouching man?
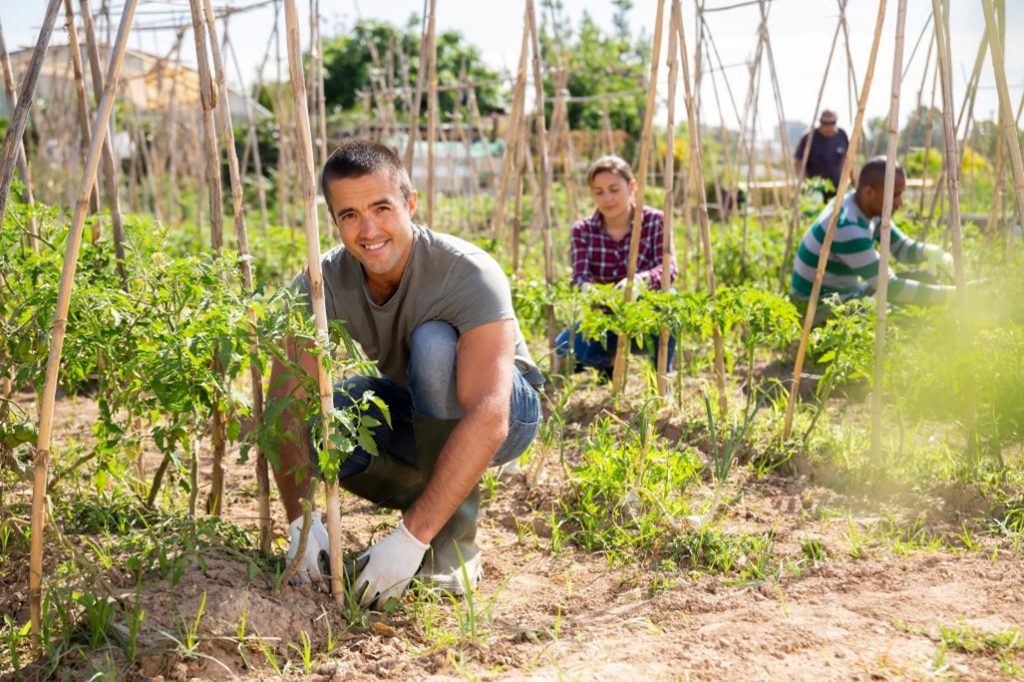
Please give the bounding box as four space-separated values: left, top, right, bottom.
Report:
334 321 541 480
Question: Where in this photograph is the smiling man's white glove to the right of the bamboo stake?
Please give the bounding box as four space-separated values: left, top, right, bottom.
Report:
355 521 430 606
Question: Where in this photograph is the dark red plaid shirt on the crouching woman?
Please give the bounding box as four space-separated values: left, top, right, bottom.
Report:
571 201 679 289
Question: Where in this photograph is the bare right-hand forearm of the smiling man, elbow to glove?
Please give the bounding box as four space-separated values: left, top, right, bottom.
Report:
403 409 508 543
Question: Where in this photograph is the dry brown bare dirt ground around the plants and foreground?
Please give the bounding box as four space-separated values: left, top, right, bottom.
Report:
0 391 1024 680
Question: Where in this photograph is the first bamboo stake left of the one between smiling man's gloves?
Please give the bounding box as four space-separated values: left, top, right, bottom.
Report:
203 0 270 554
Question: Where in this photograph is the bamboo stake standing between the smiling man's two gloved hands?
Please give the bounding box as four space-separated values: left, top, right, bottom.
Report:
285 0 345 604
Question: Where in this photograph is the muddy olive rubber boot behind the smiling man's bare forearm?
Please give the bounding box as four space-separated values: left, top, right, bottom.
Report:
410 413 482 596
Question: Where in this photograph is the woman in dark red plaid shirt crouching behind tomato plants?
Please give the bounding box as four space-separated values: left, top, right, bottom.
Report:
555 156 678 377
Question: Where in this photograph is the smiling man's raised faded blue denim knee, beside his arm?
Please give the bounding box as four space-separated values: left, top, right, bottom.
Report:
407 319 462 419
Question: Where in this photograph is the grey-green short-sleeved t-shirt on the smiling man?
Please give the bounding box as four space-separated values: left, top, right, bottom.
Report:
292 225 544 388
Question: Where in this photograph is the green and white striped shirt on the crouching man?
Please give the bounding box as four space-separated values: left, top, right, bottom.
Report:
791 191 955 305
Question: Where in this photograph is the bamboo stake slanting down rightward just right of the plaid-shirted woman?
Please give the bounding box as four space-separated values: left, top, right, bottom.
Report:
672 0 729 415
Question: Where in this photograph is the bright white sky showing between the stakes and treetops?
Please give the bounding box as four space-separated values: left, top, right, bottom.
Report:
0 0 1024 136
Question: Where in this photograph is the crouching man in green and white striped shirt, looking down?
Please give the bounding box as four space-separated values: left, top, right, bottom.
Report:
791 157 956 305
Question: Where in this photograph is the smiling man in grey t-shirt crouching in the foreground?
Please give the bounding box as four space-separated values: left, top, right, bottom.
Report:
268 140 544 604
